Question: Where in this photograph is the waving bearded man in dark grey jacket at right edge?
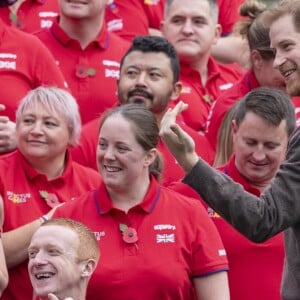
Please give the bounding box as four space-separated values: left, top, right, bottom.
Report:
160 0 300 300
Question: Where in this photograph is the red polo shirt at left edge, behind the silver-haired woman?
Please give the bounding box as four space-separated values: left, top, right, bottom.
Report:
0 18 66 121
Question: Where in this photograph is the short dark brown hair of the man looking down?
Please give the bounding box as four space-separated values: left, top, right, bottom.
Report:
235 87 296 136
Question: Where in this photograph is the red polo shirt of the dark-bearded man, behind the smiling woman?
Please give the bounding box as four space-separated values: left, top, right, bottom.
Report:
71 118 214 186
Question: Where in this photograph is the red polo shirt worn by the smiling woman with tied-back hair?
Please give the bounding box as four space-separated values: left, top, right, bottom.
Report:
54 177 228 300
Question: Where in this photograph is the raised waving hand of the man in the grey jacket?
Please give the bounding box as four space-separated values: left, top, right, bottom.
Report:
159 101 199 172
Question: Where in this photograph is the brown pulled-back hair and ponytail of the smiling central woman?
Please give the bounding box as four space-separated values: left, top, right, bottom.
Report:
99 103 163 179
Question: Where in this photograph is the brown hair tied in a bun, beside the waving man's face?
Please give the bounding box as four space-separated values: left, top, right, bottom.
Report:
234 0 275 60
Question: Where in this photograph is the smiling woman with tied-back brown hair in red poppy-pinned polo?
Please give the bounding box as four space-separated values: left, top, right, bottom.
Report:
54 104 229 300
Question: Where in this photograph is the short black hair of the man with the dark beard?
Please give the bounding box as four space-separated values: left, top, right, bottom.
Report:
120 36 180 83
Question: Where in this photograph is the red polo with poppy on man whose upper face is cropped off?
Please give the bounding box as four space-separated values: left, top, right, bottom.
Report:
36 22 130 123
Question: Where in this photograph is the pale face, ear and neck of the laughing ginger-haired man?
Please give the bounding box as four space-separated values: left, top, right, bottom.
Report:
28 225 96 300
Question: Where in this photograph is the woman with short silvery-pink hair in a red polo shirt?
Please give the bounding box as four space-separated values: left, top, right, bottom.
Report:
0 87 100 299
